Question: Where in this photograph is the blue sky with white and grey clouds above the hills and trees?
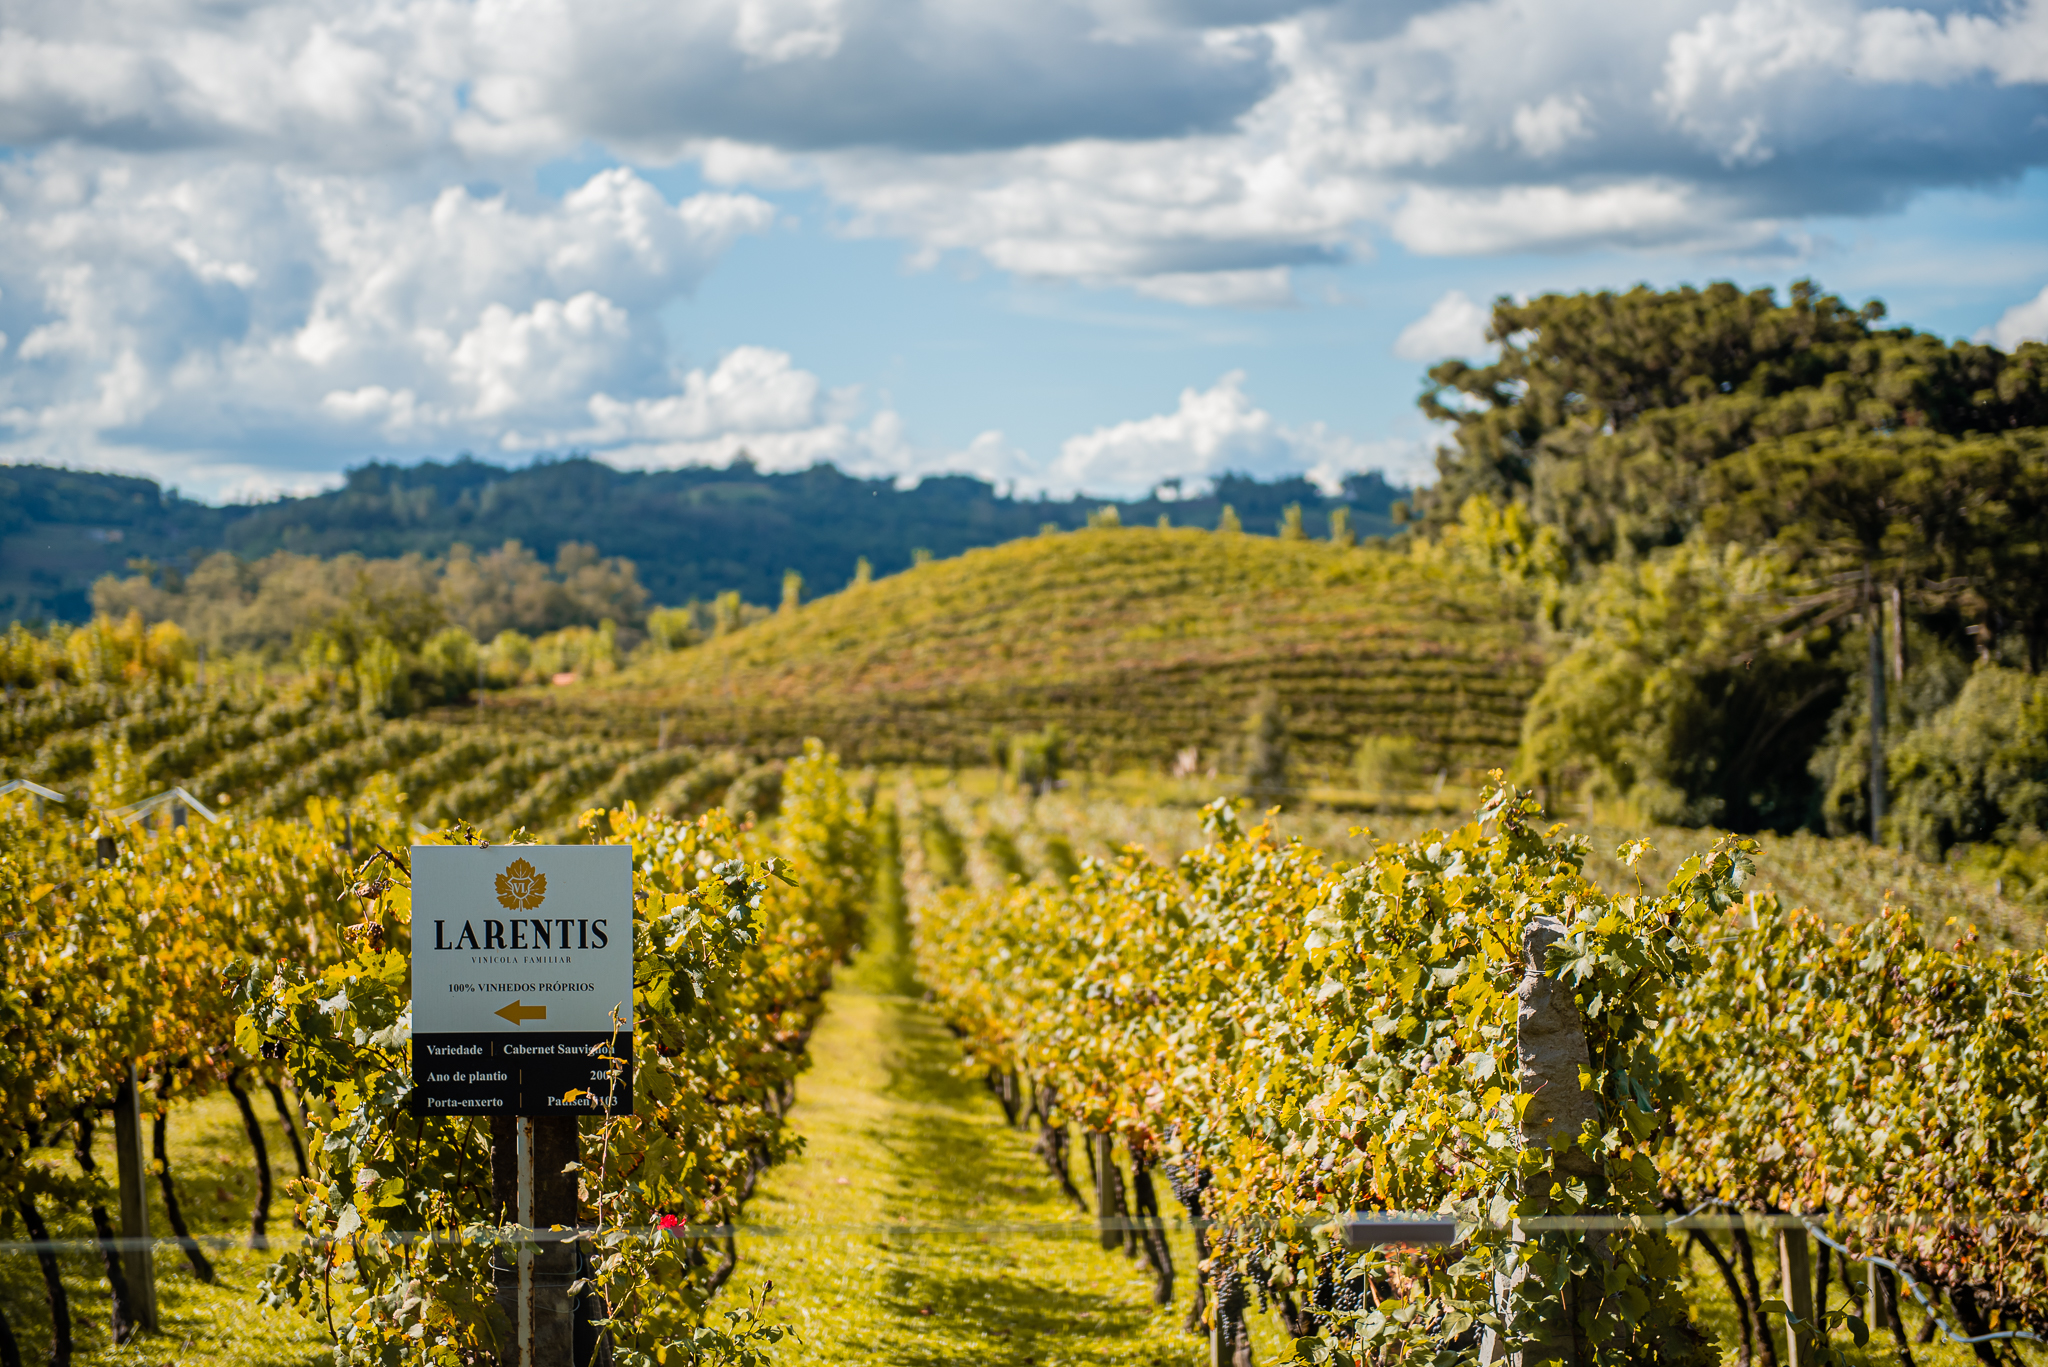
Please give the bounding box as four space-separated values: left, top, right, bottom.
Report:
0 0 2048 500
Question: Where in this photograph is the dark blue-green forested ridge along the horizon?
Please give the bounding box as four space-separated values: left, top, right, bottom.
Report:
0 457 1407 623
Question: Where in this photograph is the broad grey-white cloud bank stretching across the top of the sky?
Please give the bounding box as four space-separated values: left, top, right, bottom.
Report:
0 0 2048 321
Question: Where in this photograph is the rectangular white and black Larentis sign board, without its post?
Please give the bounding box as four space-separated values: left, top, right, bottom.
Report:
412 844 633 1115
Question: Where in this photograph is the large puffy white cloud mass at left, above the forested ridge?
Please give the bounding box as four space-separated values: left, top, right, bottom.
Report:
0 150 774 488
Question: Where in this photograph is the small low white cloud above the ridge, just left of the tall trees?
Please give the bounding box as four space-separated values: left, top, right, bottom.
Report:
1040 371 1417 494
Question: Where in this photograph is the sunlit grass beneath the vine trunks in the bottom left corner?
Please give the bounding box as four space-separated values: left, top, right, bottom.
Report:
0 1088 334 1367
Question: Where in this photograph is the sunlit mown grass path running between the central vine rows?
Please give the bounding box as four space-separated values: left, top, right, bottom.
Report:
735 930 1286 1367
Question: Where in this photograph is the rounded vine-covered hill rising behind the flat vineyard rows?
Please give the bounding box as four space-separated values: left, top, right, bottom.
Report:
536 529 1542 773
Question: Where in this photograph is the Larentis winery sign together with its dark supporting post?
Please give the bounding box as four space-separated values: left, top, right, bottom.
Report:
412 844 633 1367
